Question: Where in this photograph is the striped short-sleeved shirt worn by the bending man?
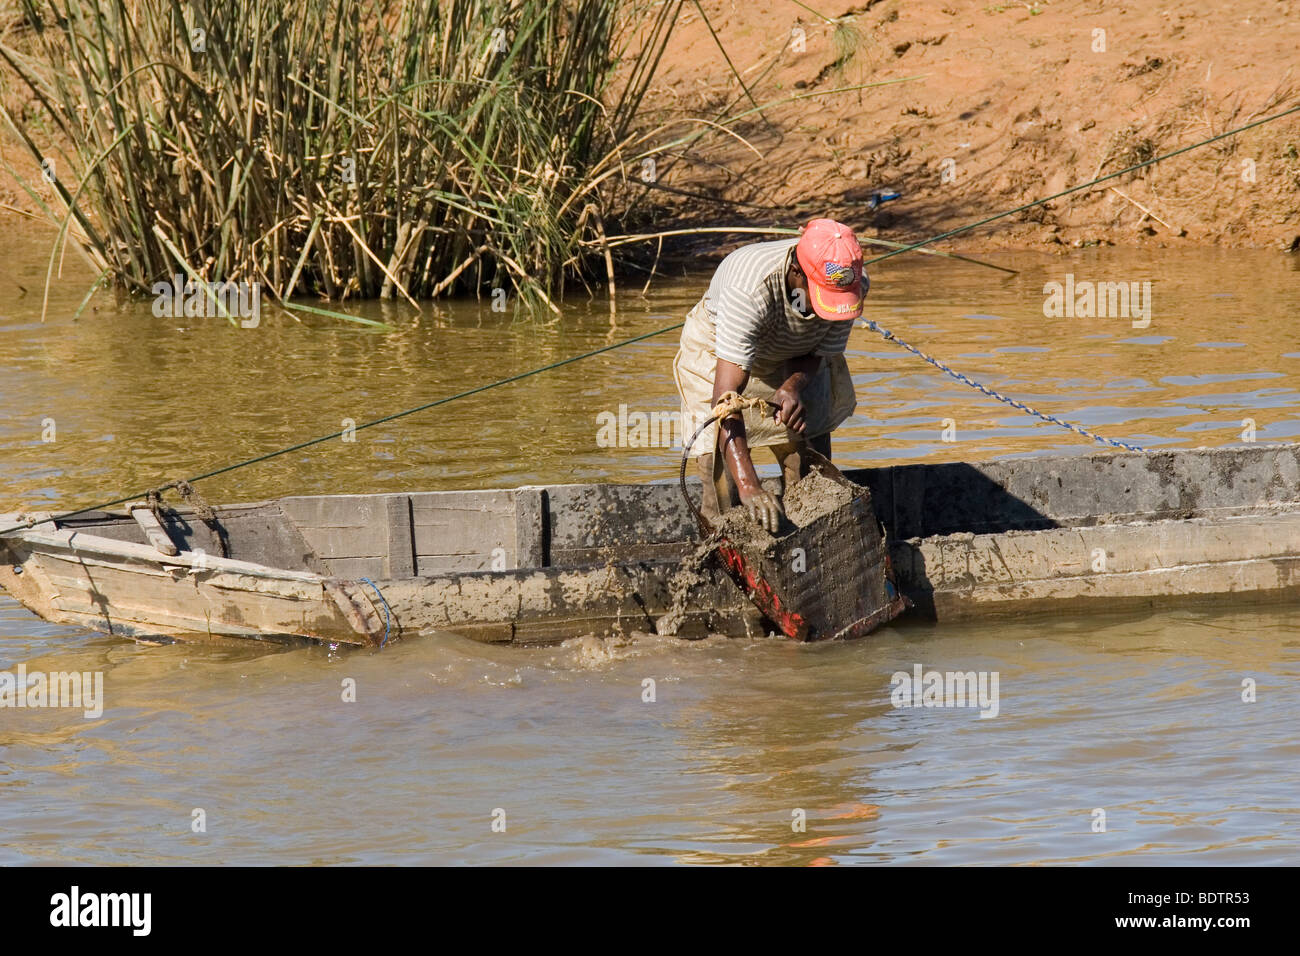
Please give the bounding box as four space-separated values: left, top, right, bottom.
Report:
705 239 853 372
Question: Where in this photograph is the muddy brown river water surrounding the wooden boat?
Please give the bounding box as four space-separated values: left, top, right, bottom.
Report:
0 230 1300 865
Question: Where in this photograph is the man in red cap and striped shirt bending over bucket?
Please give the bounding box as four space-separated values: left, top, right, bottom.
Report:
673 219 868 532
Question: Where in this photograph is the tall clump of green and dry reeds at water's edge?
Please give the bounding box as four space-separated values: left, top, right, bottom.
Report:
0 0 680 307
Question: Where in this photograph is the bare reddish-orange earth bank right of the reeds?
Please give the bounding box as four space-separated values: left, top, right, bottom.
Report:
624 0 1300 252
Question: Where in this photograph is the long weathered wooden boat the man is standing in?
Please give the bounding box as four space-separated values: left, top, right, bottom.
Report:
0 445 1300 645
